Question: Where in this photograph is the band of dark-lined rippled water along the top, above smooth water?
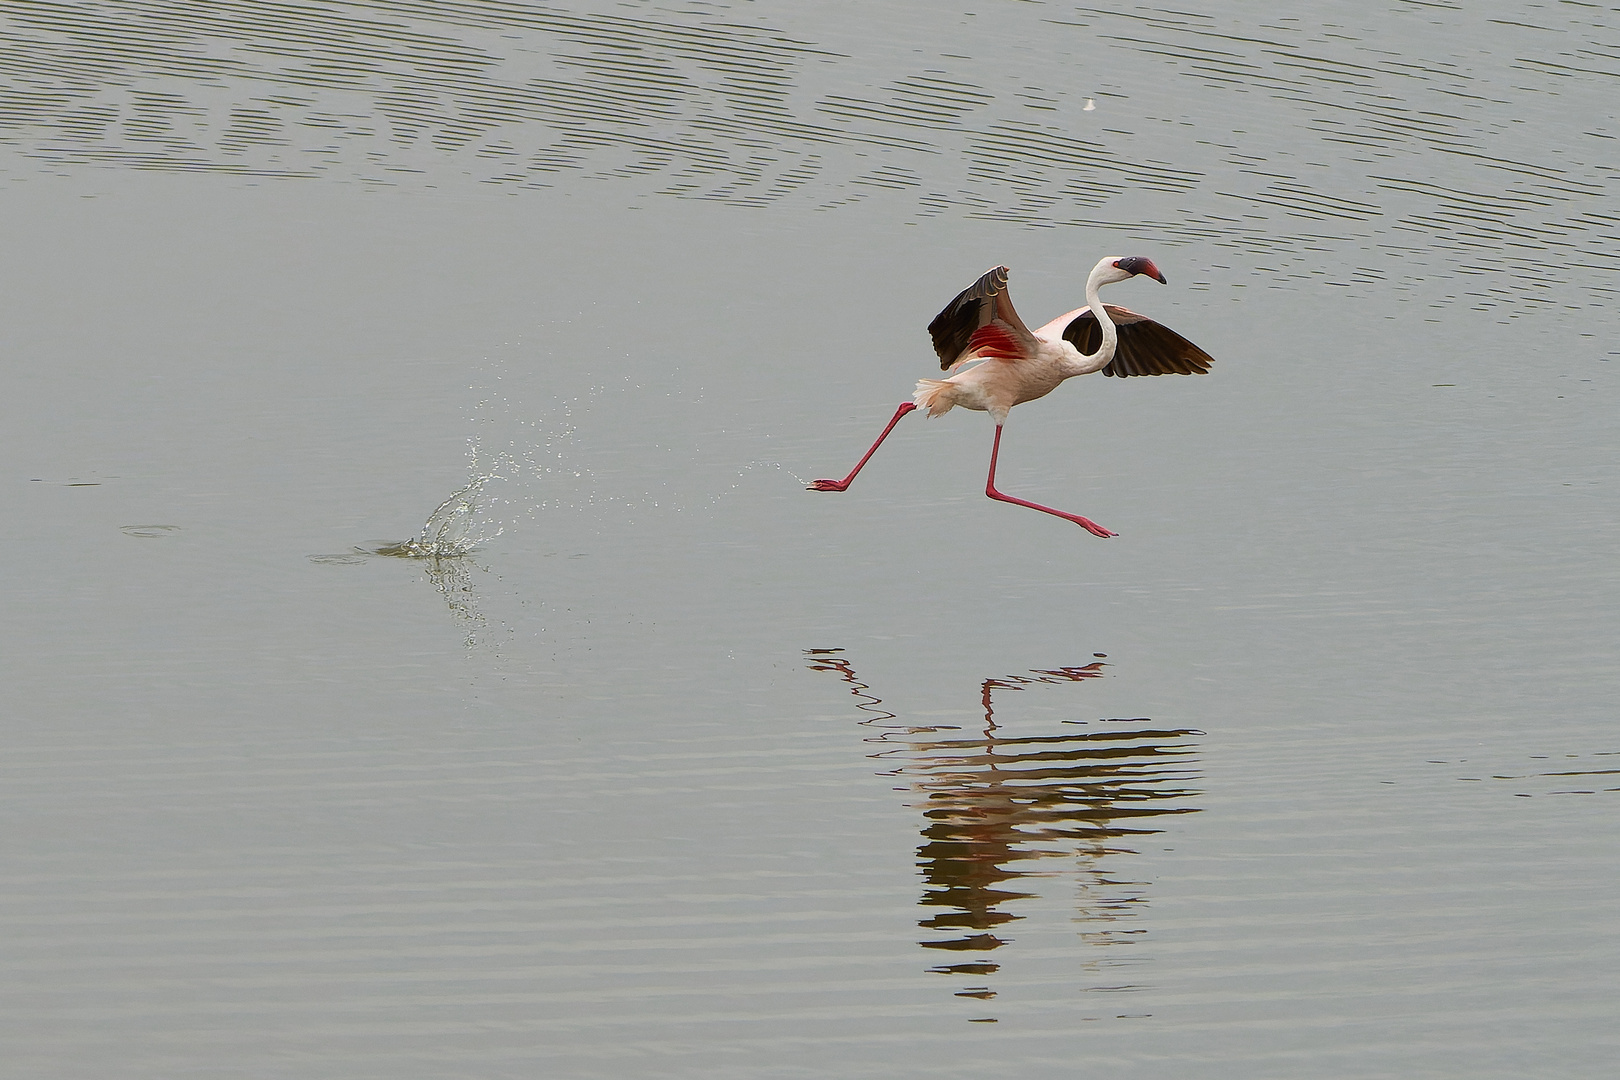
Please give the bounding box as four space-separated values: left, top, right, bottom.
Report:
0 0 1620 307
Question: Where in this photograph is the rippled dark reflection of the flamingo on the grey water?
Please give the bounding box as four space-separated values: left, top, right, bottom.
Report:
807 649 1202 1016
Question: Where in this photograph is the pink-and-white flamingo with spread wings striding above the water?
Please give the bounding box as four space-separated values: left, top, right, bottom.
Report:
810 256 1215 536
